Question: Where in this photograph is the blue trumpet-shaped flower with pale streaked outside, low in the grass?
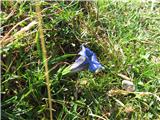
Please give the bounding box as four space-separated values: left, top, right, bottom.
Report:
70 45 104 73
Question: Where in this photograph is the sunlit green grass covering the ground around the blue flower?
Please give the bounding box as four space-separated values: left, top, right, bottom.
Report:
0 0 160 120
